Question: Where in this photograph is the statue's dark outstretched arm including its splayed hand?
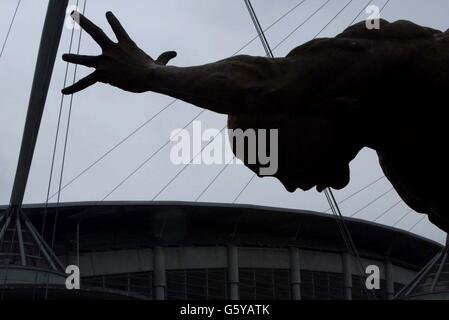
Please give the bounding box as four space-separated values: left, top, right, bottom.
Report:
62 12 290 114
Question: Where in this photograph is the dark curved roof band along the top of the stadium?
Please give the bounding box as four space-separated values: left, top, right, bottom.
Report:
0 202 441 267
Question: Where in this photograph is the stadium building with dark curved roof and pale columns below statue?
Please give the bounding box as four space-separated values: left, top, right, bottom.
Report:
0 202 442 300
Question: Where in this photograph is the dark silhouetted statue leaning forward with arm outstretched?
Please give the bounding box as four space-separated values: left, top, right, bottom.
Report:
63 12 449 231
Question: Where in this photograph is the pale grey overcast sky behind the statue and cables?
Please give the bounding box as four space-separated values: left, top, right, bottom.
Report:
0 0 449 242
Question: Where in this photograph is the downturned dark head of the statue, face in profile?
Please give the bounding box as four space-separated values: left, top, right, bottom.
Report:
229 100 363 192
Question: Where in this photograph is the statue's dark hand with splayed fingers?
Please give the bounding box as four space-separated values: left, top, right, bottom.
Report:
62 12 176 94
